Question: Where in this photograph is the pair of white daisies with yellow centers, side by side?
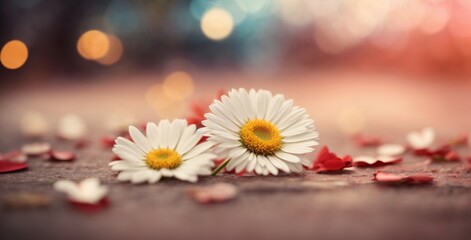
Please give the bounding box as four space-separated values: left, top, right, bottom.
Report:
109 89 318 183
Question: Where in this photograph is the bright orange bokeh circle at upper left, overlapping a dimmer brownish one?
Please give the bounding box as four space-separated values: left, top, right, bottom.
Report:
77 30 110 60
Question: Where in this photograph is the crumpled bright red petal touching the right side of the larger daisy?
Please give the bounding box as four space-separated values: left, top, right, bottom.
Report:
309 146 352 173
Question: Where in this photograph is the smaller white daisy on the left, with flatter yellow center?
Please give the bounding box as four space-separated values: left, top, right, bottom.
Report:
109 119 216 183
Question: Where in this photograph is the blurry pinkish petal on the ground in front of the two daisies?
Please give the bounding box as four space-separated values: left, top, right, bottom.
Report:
187 183 238 204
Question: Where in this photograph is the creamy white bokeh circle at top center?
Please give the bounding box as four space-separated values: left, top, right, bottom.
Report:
200 8 234 41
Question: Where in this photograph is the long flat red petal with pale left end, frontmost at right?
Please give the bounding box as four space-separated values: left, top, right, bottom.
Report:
373 171 433 184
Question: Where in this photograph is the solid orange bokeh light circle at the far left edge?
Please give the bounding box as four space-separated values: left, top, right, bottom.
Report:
0 40 28 70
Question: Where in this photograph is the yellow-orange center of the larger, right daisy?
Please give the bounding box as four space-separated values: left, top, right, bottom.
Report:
239 119 281 156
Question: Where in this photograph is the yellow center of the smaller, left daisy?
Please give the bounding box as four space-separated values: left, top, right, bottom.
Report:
146 148 182 170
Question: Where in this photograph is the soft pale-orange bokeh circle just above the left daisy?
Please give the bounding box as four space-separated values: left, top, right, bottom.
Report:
163 71 193 100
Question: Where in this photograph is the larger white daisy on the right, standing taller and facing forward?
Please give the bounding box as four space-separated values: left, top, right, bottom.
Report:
203 89 319 175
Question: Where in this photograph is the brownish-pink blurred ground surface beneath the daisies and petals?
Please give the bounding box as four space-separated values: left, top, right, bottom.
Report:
0 71 471 240
